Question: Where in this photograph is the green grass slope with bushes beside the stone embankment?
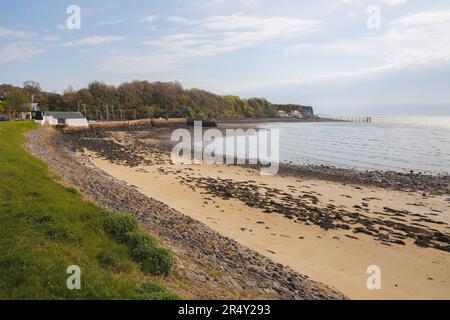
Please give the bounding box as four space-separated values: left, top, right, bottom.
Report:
0 122 178 299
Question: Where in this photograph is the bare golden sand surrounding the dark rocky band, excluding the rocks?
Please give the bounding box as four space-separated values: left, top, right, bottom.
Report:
87 148 450 299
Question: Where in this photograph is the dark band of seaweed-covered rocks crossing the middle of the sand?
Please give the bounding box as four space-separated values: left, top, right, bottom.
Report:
179 177 450 252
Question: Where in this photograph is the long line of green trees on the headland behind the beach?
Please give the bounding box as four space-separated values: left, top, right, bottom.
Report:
0 81 276 121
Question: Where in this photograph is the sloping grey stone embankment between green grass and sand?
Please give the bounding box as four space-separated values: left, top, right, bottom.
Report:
27 129 345 300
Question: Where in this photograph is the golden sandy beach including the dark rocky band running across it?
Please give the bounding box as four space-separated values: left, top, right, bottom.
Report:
69 128 450 299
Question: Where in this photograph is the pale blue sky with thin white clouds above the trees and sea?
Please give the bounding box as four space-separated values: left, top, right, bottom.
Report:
0 0 450 116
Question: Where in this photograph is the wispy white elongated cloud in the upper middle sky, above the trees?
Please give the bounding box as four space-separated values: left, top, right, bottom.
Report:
105 15 321 73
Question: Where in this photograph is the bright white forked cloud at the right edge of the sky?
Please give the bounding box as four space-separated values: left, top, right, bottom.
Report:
251 11 450 87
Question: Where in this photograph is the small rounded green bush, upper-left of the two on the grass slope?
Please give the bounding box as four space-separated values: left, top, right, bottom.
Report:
104 213 139 243
